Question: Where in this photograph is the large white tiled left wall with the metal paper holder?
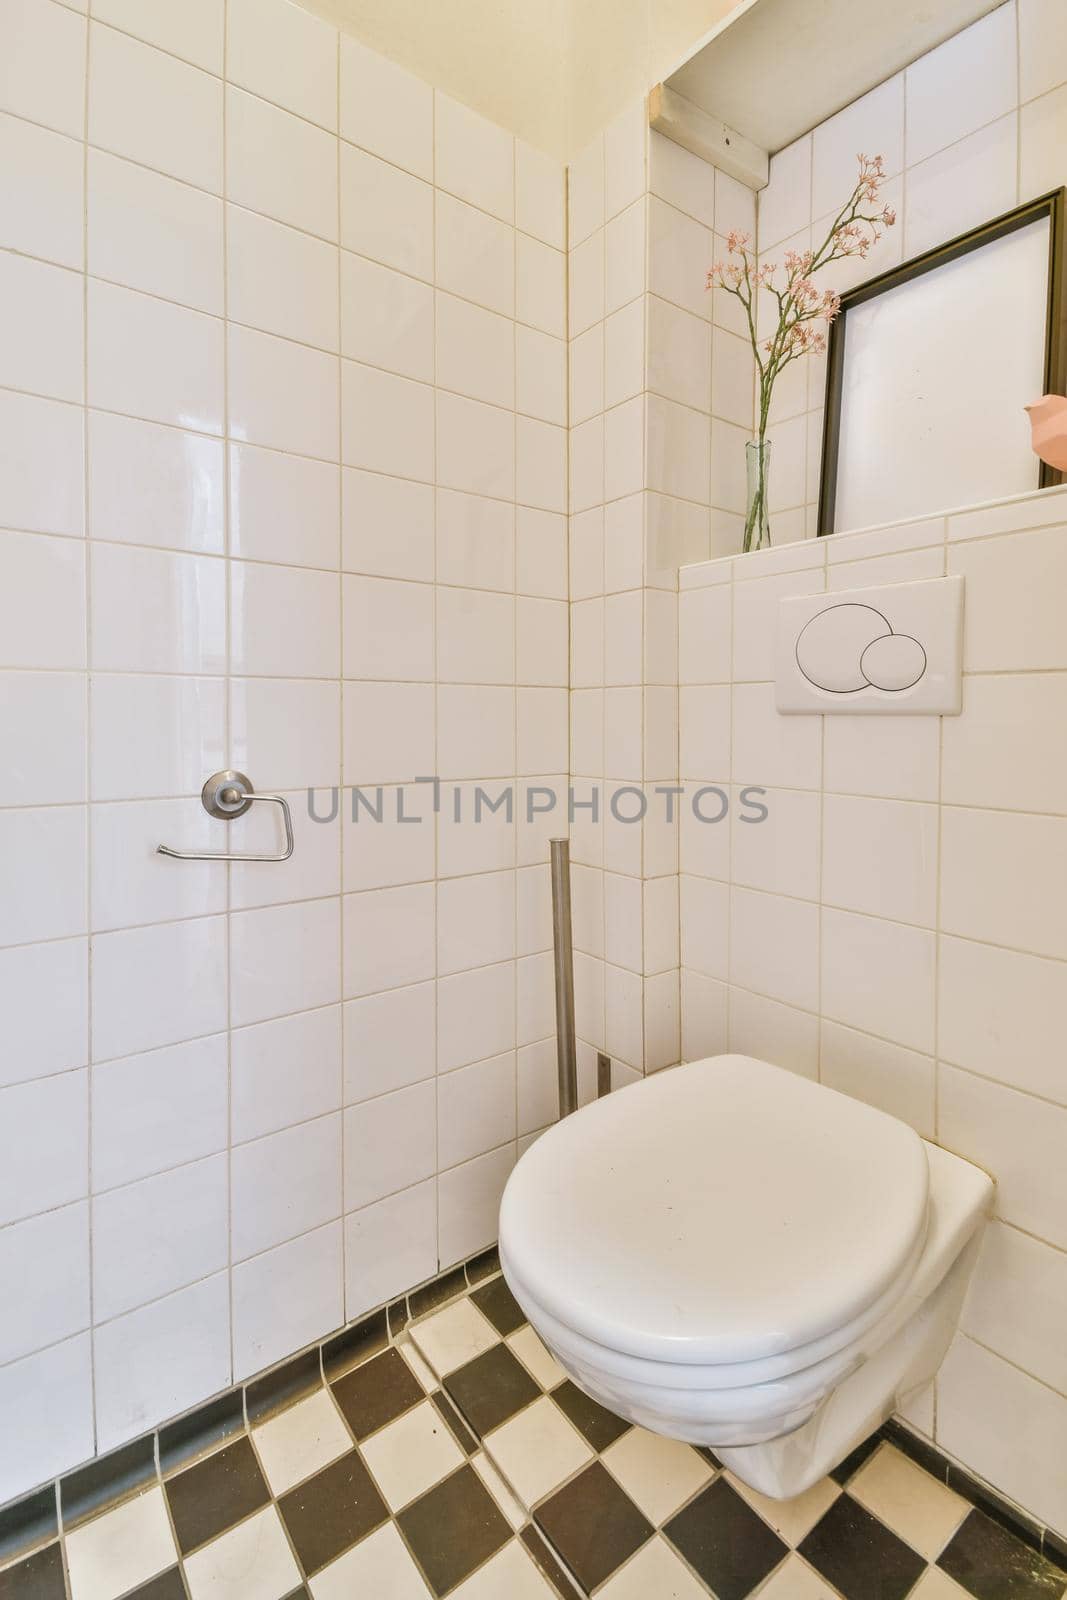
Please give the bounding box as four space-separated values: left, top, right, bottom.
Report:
0 0 568 1501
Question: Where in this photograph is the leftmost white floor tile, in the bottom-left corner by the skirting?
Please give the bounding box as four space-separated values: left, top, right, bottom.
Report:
66 1486 177 1600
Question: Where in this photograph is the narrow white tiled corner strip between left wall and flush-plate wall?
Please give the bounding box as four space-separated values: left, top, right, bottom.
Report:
568 102 755 1093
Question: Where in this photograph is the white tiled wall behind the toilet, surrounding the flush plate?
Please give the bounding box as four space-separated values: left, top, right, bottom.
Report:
678 490 1067 1531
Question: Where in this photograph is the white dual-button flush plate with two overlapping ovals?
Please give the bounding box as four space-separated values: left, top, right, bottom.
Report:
776 576 963 717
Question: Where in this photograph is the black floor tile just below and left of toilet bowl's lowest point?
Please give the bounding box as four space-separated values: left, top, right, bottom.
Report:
664 1478 787 1600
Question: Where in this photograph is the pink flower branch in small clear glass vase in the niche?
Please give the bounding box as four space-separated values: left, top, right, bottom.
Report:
707 154 896 550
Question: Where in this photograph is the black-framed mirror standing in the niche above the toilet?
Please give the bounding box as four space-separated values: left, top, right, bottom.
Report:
819 189 1067 534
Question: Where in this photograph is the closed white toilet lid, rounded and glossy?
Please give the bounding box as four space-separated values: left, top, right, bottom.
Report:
501 1056 928 1363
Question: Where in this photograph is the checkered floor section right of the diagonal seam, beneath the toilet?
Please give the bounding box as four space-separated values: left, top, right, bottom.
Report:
411 1277 1067 1600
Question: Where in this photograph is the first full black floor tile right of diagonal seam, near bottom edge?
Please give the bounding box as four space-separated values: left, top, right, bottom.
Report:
534 1461 654 1592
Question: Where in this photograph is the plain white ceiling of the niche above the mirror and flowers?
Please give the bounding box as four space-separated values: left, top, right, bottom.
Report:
664 0 1003 152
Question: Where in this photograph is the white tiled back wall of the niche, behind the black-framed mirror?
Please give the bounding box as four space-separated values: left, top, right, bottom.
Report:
758 0 1067 544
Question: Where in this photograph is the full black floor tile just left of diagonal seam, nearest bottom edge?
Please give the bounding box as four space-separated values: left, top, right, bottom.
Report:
397 1467 512 1595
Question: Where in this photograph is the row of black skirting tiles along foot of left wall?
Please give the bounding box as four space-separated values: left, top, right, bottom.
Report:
0 1246 499 1570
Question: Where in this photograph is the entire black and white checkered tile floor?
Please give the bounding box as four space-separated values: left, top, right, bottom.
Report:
0 1277 1067 1600
